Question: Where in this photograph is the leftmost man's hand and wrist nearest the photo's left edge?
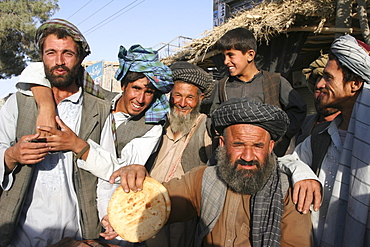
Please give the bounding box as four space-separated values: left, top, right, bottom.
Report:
4 134 50 172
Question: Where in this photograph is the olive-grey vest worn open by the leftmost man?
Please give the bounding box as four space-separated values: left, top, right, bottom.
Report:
0 93 110 246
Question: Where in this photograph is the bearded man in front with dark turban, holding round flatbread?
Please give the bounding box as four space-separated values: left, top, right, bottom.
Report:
113 98 311 246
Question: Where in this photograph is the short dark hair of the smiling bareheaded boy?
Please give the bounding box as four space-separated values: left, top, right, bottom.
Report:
216 27 257 54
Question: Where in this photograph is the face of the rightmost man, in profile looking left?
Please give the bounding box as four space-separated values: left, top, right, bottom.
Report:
316 60 353 109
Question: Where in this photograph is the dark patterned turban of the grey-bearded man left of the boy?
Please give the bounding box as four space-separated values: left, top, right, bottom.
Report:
171 61 213 93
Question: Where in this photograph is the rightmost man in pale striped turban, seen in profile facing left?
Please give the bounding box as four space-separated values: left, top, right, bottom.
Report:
282 35 370 246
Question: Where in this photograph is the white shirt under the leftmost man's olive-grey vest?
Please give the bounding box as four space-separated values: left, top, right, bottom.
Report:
0 89 114 246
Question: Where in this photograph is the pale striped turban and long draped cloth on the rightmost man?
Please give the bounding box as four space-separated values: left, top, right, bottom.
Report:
322 35 370 246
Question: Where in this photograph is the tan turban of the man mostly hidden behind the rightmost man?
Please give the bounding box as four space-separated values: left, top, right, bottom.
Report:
302 54 329 92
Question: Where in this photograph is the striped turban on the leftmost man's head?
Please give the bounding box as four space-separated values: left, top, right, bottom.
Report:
35 19 91 57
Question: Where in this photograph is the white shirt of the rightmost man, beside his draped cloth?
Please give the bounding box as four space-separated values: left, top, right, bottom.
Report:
280 116 348 246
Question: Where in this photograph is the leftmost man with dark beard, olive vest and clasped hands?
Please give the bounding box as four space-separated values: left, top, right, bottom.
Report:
0 19 114 246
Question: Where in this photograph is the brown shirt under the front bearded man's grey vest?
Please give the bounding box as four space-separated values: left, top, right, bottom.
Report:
164 166 311 246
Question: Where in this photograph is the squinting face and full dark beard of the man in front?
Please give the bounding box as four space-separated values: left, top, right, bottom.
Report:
216 124 276 195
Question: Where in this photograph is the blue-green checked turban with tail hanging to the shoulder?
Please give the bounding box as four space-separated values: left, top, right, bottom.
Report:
116 45 173 123
